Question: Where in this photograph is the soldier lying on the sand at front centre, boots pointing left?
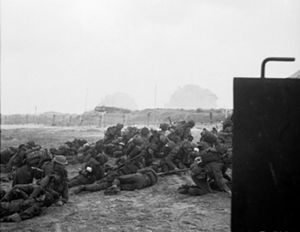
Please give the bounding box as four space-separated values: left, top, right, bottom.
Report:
104 168 158 195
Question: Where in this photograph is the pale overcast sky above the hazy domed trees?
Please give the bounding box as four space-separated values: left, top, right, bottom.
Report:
1 0 300 114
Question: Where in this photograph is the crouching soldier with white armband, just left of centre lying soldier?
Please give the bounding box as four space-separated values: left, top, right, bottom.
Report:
68 154 108 188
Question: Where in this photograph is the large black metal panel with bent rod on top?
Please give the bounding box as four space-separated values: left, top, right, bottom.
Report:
231 58 300 232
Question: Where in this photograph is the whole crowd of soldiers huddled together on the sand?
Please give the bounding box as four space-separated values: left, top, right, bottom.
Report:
0 115 233 222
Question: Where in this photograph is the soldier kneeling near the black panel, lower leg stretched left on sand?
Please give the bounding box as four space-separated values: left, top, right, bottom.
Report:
178 156 212 196
